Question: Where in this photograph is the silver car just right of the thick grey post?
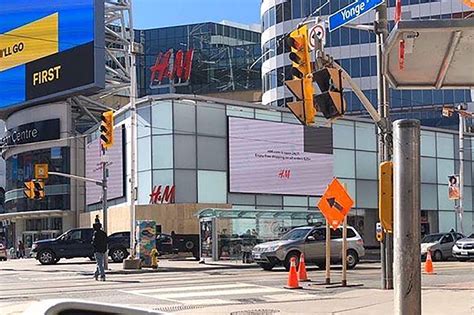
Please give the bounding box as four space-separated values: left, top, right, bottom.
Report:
421 231 464 261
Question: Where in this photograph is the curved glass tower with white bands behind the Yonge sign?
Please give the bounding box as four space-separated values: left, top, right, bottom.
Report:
261 0 472 128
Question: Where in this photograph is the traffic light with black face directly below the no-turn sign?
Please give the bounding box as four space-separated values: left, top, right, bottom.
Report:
313 67 346 119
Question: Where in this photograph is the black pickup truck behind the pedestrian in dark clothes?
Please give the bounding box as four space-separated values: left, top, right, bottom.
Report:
31 228 130 265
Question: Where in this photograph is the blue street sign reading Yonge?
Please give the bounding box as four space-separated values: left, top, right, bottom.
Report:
329 0 384 32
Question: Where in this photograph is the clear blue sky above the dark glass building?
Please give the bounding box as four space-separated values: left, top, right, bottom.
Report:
132 0 261 29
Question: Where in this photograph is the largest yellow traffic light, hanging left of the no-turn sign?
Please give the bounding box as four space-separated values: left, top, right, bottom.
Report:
285 25 316 125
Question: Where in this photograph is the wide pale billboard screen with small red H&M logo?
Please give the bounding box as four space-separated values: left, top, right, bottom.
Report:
228 117 333 196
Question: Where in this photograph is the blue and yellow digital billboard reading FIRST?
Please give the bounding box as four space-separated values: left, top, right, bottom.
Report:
0 0 105 110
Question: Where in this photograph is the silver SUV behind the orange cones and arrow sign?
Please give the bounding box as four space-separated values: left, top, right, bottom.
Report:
252 226 365 270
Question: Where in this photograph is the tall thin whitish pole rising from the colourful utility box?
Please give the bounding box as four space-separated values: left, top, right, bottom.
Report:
129 1 137 257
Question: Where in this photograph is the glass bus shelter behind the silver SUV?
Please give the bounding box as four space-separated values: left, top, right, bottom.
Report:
197 208 323 261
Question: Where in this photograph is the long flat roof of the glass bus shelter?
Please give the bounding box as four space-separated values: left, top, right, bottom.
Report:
196 208 323 222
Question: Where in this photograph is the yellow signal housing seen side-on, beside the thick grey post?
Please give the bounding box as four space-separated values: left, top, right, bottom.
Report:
379 161 393 233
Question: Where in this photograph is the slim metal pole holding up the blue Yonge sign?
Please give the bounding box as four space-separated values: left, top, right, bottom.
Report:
375 2 393 289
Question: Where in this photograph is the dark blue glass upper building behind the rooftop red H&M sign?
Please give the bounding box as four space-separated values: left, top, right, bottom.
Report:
136 23 261 96
